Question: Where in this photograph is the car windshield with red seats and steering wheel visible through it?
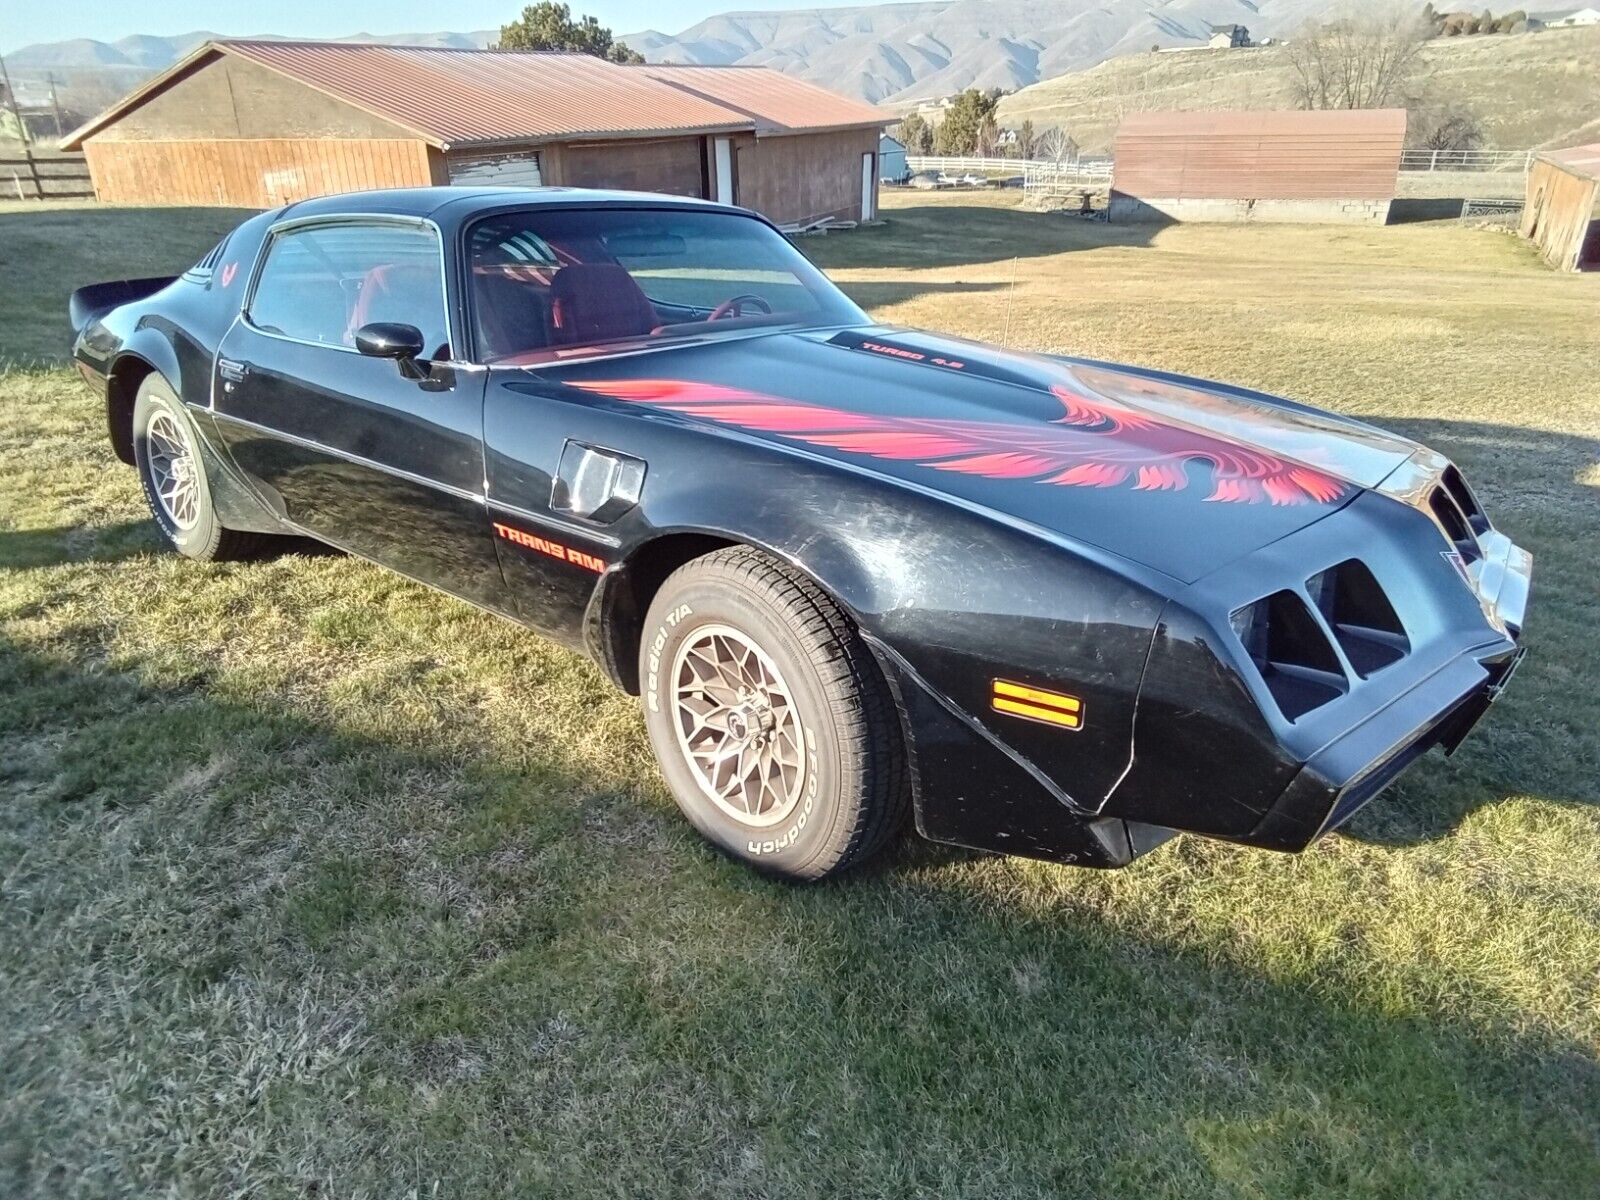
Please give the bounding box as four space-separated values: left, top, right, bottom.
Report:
467 208 866 363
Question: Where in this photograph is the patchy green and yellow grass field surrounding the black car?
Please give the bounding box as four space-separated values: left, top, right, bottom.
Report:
0 195 1600 1200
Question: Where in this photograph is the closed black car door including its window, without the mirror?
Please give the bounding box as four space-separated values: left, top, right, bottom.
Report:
213 219 507 610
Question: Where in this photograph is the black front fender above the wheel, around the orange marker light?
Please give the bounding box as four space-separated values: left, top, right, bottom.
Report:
590 430 1165 866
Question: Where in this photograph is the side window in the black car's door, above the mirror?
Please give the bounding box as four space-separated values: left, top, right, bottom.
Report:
250 222 450 358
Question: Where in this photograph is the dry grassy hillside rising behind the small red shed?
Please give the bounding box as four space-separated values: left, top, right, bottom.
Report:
1000 27 1600 154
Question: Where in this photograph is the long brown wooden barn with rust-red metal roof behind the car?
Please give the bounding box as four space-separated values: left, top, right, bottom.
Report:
62 40 891 224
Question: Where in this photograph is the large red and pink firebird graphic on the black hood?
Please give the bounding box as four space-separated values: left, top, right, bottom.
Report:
570 379 1346 504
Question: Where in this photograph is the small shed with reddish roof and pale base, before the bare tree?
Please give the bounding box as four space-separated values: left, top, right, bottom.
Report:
1110 109 1405 224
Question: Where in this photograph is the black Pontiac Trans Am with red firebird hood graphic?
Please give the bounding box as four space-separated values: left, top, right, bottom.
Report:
72 189 1530 878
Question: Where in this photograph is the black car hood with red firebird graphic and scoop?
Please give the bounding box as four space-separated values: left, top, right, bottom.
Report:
558 326 1416 581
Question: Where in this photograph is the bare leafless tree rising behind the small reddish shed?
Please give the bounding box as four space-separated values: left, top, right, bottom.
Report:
1285 11 1427 109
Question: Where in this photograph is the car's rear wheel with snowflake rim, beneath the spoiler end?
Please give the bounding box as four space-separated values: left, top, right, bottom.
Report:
133 374 269 562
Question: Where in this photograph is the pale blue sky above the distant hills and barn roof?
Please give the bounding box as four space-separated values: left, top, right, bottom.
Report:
0 0 825 53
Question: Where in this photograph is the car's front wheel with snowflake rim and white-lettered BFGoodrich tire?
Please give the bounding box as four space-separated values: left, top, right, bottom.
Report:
640 547 907 880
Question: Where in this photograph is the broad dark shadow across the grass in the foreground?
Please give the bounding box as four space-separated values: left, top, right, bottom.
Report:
0 635 1600 1197
